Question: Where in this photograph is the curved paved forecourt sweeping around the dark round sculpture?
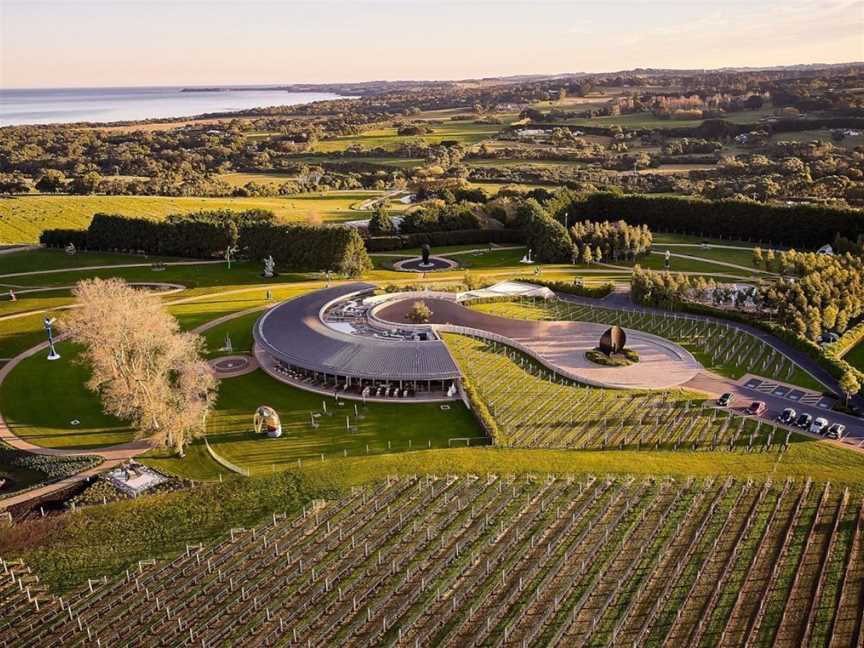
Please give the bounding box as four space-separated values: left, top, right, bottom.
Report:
375 298 701 389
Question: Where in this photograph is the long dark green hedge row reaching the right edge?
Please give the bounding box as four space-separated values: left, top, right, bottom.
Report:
556 192 864 248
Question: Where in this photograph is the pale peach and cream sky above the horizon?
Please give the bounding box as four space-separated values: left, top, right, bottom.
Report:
0 0 864 88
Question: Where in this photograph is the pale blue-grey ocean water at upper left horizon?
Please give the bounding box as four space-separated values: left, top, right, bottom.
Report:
0 86 338 126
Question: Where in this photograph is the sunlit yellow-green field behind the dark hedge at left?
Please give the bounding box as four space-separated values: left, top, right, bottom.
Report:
0 191 382 243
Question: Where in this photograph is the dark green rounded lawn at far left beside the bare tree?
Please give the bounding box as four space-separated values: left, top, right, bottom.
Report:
0 342 133 449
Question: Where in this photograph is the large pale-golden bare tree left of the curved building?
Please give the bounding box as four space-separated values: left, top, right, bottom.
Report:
61 279 218 452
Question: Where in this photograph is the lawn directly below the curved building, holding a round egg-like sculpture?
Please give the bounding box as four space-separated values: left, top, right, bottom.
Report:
207 370 483 473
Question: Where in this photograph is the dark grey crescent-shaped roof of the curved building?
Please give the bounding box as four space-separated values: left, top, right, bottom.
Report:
252 282 460 380
